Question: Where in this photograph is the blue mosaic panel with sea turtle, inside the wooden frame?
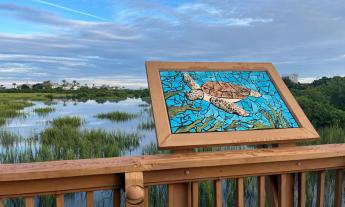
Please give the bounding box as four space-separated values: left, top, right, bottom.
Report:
160 71 299 134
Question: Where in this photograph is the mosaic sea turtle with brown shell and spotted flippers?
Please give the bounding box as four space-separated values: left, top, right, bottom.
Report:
183 73 261 116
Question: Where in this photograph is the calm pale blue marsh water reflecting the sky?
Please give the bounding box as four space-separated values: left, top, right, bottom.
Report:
0 99 156 155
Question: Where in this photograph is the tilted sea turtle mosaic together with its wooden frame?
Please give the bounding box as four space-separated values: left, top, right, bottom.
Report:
146 62 318 149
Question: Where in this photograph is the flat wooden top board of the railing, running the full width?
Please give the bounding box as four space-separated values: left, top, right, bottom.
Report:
0 144 345 181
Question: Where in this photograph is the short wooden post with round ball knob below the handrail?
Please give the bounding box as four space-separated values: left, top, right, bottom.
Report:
125 172 145 207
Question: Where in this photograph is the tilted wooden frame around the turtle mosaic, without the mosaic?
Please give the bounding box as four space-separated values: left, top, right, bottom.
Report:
146 61 319 149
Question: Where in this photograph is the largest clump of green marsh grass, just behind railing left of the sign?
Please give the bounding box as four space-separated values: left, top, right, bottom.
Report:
39 117 140 160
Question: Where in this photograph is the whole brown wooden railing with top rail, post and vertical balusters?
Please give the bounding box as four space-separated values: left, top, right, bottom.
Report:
0 144 345 207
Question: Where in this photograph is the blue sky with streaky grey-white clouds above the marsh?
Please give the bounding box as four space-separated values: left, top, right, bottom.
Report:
0 0 345 88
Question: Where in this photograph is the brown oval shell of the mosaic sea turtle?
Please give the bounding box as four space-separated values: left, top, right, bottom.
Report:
201 82 251 99
